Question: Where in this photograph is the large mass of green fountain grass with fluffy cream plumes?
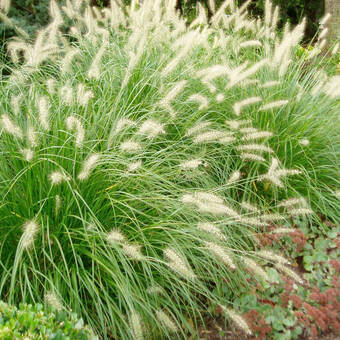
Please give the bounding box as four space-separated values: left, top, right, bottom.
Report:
0 0 339 339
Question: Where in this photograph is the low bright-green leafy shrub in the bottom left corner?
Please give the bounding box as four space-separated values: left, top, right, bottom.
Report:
0 301 97 340
